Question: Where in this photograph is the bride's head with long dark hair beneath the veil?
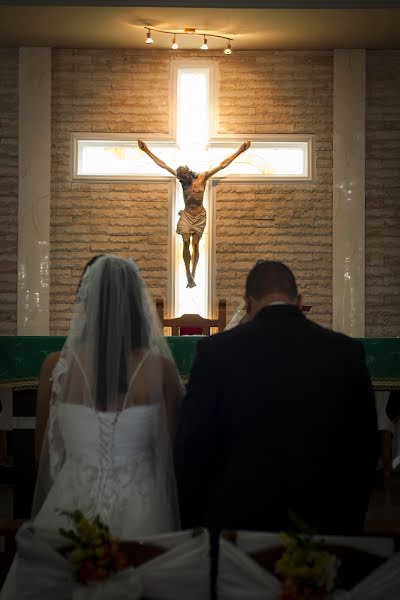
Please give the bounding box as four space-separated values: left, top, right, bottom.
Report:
79 254 154 410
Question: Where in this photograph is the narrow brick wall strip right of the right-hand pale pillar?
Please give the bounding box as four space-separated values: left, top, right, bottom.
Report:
365 50 400 337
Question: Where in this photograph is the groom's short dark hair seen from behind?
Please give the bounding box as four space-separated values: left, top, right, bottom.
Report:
246 260 298 300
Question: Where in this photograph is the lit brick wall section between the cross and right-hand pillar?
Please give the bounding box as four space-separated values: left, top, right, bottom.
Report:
216 52 333 326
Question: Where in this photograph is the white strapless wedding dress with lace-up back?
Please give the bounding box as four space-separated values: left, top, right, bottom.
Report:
34 372 177 539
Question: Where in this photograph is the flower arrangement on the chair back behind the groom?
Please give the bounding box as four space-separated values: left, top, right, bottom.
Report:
275 515 340 600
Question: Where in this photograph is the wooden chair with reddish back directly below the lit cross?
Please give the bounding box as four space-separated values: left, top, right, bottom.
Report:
156 298 226 335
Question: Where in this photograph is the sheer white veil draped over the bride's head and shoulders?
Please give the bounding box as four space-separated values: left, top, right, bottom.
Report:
32 255 182 526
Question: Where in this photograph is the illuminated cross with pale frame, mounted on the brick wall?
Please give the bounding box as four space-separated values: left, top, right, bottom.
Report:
74 61 311 317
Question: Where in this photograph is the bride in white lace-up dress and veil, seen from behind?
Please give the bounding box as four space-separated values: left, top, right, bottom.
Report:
2 255 182 598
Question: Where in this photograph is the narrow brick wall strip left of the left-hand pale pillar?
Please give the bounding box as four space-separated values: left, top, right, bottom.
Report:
0 48 18 335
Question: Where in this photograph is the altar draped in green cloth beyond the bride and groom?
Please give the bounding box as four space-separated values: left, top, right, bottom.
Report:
0 336 400 518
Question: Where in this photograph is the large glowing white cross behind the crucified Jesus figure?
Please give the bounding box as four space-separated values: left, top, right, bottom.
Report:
75 64 310 317
